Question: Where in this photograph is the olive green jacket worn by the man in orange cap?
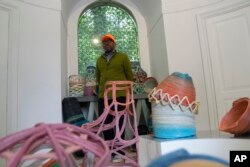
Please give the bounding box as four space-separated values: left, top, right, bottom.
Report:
96 52 133 98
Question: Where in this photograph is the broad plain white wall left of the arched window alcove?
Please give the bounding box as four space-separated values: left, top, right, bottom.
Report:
0 0 62 133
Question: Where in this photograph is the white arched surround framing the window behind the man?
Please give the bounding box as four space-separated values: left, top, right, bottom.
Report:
66 0 151 76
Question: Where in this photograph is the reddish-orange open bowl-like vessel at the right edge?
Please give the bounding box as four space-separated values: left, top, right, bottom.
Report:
219 97 250 135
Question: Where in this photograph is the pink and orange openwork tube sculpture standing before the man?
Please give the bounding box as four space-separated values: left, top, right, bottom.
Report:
82 81 139 166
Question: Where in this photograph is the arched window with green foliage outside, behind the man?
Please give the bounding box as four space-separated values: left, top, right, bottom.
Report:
78 1 140 75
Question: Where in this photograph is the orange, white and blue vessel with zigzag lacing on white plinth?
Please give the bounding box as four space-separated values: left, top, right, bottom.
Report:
148 72 198 138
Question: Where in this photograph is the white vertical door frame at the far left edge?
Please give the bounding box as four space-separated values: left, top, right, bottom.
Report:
0 1 20 134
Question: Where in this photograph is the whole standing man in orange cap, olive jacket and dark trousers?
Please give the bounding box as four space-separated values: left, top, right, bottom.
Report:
96 34 133 162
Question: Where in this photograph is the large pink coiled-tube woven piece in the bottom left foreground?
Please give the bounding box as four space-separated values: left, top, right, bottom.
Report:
0 124 110 167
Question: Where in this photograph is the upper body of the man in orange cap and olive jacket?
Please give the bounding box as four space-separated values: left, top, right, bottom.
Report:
96 34 133 98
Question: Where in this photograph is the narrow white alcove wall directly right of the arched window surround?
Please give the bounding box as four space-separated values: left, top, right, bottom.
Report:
140 0 169 82
